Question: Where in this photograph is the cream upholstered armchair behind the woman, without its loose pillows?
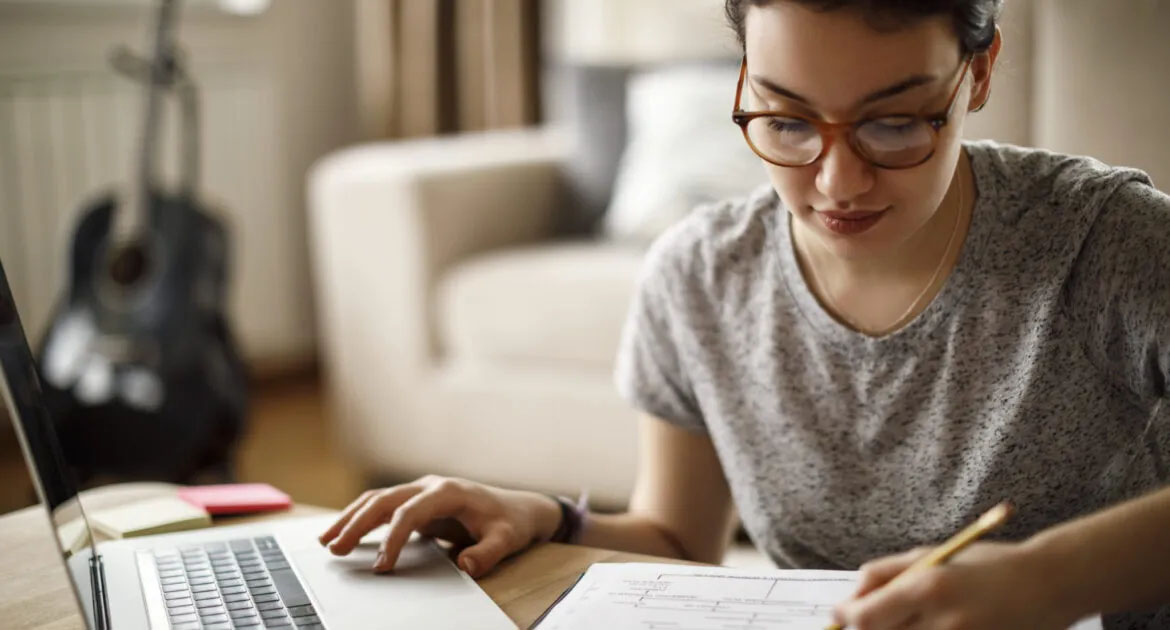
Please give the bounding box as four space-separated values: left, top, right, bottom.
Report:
309 130 641 505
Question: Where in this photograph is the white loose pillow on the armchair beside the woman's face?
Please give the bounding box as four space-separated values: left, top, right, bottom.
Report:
605 63 768 242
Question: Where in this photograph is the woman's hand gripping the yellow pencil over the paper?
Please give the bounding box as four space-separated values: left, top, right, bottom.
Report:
833 542 1078 630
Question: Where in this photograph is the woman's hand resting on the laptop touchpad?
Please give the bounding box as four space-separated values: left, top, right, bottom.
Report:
318 475 560 577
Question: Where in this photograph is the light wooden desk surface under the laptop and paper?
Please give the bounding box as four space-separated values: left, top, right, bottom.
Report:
0 484 679 630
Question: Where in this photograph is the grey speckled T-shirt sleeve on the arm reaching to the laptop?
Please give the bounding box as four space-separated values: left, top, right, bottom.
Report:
614 231 707 432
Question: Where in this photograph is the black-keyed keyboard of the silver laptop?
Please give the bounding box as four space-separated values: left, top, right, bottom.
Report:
153 536 324 630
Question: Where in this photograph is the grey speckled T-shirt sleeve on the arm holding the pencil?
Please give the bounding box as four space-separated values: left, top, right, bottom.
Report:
1068 180 1170 404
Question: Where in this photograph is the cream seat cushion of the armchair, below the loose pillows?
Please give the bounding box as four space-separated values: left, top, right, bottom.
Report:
435 241 642 370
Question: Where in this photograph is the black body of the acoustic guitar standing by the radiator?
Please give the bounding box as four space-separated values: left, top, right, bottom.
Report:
39 192 247 482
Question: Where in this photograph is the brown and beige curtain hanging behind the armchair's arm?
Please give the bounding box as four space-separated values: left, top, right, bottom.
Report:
355 0 541 138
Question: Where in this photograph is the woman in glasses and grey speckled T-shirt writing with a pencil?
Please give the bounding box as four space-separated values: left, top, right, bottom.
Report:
322 0 1170 630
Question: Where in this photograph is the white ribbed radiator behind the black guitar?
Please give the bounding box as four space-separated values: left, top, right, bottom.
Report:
0 63 304 363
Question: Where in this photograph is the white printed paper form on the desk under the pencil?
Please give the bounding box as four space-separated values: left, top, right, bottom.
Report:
536 563 1101 630
